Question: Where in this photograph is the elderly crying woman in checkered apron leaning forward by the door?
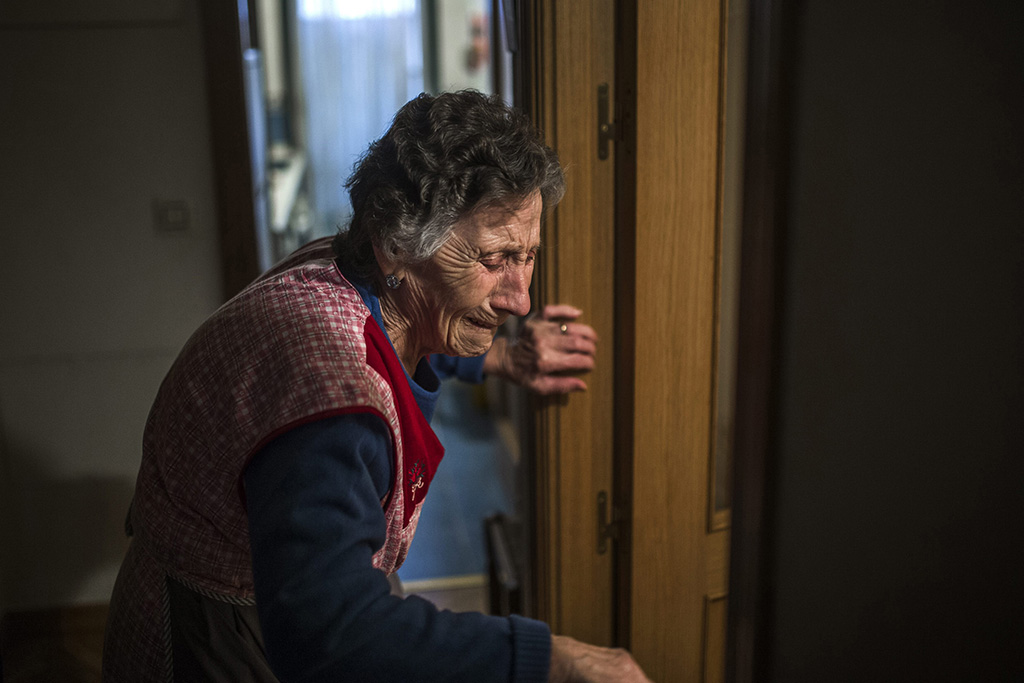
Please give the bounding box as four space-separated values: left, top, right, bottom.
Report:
103 92 646 683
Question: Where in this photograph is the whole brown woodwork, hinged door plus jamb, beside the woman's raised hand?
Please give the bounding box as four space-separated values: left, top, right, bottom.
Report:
525 0 741 681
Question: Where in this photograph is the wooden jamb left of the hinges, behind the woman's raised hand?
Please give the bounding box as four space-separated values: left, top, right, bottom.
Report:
516 0 617 645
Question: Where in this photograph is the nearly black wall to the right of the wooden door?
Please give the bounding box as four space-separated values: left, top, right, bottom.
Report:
770 0 1024 683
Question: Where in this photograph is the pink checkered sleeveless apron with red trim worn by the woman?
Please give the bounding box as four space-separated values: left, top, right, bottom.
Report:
103 240 443 683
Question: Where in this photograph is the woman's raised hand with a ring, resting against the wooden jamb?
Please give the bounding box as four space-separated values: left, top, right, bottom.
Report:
483 304 597 395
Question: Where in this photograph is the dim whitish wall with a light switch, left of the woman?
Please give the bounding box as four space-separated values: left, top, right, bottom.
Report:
0 0 220 610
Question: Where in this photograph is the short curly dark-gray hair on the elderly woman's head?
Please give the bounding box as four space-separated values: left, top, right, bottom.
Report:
333 90 565 279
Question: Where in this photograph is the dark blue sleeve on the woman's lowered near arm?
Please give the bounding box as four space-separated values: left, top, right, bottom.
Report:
244 414 551 683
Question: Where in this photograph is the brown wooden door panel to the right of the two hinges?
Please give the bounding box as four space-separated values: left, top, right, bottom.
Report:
618 0 738 681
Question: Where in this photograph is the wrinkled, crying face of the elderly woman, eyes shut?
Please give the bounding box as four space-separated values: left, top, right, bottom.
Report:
402 191 543 356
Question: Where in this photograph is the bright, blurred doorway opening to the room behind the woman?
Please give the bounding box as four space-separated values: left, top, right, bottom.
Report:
246 0 529 611
